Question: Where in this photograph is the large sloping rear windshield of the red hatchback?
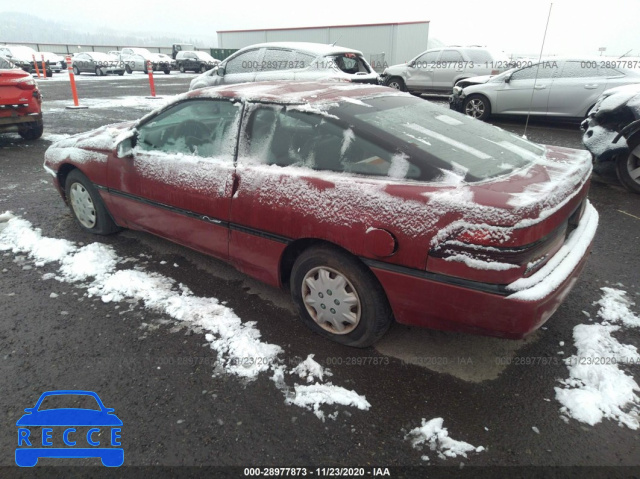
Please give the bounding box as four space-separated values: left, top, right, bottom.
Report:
330 96 545 182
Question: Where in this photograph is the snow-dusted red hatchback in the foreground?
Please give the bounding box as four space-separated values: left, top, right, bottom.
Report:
45 82 598 347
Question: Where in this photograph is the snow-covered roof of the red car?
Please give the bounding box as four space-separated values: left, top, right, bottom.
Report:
187 81 400 104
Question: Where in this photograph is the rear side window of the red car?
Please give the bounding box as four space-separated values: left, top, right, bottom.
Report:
245 106 420 178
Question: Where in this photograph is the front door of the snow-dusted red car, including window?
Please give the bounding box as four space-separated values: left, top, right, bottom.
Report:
108 98 242 259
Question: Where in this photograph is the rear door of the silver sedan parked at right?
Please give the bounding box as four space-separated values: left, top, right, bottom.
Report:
548 60 607 118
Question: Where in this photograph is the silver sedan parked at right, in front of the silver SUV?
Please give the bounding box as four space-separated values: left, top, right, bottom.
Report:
450 58 640 120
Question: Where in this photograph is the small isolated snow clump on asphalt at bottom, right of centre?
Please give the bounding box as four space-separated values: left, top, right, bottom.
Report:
405 417 484 461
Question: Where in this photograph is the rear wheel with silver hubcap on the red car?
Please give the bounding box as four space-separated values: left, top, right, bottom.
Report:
290 246 393 348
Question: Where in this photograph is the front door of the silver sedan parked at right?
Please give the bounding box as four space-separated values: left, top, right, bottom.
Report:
491 62 561 115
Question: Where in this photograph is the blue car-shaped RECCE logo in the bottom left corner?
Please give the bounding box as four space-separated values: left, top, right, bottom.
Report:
16 390 124 467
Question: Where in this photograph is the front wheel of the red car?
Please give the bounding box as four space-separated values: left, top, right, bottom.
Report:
65 170 120 235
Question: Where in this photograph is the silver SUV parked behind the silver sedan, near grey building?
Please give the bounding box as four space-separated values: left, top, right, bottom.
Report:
380 46 512 94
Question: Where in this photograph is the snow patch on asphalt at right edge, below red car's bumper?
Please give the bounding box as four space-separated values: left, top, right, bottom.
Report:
555 288 640 430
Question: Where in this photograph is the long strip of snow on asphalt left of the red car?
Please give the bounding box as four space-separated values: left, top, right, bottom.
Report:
0 212 371 421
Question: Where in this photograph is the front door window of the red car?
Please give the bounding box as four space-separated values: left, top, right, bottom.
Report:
136 100 240 161
